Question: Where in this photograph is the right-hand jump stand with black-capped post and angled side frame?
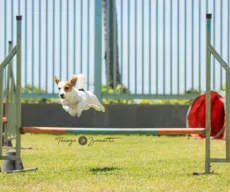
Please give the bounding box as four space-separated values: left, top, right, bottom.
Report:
204 14 230 174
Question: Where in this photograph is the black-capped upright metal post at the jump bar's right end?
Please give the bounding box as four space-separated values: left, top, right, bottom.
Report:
205 14 212 173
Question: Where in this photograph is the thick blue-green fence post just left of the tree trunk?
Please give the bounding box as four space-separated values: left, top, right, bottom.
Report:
94 0 102 101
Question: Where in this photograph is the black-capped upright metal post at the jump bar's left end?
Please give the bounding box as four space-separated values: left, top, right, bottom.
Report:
16 16 22 170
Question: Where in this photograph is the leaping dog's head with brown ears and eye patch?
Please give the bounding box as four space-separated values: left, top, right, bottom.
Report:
54 76 77 99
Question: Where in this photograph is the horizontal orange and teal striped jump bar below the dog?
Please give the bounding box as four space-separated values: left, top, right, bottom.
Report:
21 127 205 135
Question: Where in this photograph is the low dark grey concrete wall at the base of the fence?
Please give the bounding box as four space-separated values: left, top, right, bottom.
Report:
22 104 188 128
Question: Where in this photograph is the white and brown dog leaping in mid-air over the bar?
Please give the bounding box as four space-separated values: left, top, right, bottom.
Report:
54 74 105 117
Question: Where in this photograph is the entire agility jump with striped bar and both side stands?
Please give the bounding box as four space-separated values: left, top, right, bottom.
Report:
0 14 230 175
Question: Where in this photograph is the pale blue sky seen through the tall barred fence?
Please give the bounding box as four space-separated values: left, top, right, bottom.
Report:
0 0 230 94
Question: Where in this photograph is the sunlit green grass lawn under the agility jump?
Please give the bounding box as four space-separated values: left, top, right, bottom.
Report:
0 134 230 192
